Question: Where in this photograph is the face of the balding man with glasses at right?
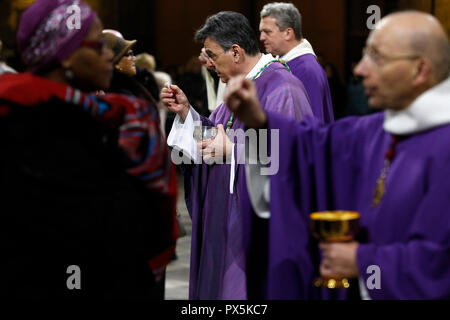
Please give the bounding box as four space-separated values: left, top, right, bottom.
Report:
354 20 418 110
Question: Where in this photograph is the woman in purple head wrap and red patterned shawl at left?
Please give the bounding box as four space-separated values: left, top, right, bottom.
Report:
0 0 177 299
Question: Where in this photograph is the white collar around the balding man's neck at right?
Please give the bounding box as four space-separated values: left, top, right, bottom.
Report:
383 78 450 135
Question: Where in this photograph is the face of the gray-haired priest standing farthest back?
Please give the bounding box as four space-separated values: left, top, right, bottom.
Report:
259 16 289 56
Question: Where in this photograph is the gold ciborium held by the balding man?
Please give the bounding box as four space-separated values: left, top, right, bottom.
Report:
310 211 359 289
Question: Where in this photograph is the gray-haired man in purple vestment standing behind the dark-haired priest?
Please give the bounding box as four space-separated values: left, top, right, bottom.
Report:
259 2 334 123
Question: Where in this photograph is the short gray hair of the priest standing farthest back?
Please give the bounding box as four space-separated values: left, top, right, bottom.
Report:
261 2 303 40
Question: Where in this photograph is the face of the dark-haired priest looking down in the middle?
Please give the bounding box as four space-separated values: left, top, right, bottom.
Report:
204 37 239 83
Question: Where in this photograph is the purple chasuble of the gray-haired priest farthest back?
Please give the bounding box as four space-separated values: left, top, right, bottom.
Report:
287 54 334 123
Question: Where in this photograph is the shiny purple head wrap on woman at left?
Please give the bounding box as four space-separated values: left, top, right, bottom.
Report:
17 0 97 73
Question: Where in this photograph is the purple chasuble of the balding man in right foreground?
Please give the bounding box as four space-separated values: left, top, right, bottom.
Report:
255 113 450 299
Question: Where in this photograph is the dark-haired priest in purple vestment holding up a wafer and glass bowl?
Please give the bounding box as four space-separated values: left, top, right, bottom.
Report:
161 12 312 299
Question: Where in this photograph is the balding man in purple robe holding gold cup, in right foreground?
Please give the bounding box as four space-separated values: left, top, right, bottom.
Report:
227 11 450 299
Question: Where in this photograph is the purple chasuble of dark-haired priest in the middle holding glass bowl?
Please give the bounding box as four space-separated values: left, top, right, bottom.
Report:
184 63 312 300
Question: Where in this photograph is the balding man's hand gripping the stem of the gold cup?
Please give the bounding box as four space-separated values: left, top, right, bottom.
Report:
319 242 359 278
